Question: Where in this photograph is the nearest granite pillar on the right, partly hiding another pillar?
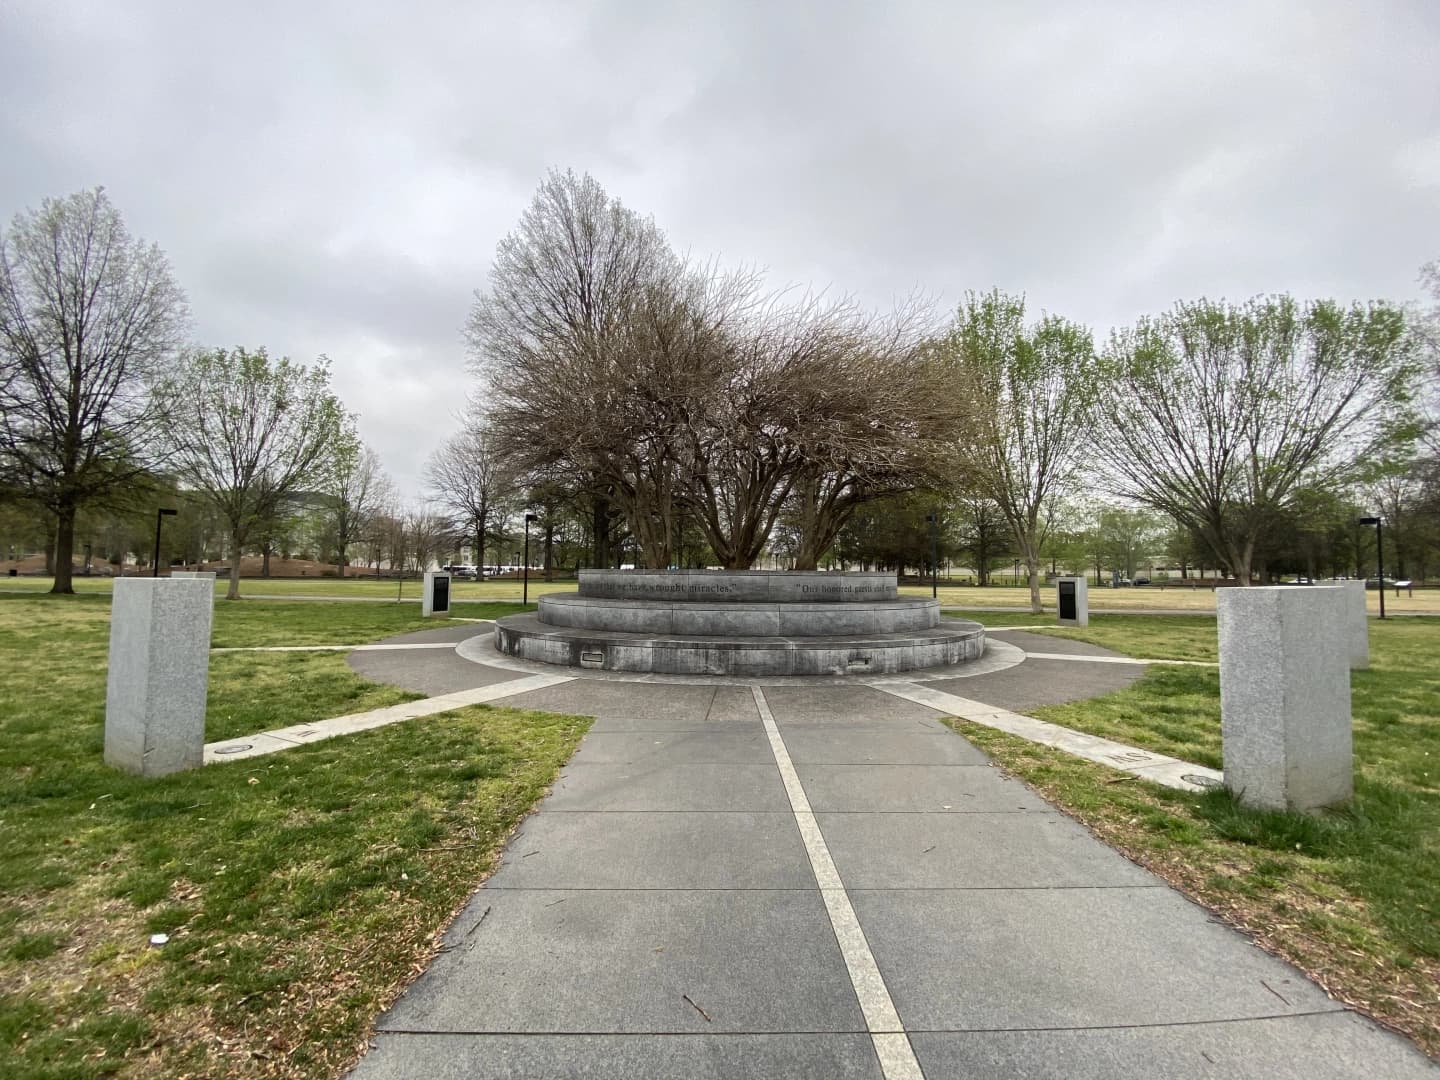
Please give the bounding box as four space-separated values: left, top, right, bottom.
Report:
1215 586 1354 811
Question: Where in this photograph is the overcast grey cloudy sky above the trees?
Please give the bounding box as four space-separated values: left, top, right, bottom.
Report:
0 0 1440 495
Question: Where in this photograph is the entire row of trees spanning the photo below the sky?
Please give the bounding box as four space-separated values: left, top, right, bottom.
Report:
0 171 1440 609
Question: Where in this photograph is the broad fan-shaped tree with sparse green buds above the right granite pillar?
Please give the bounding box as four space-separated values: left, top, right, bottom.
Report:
1096 297 1423 585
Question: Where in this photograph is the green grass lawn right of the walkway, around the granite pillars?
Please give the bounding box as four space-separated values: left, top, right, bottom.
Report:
952 616 1440 1056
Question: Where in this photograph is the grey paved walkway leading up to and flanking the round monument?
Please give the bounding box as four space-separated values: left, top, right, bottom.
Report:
342 629 1440 1080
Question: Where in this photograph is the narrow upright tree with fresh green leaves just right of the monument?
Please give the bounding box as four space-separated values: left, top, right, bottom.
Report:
940 291 1100 613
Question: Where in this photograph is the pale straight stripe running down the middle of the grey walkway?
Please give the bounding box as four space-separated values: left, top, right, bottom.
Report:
750 685 924 1080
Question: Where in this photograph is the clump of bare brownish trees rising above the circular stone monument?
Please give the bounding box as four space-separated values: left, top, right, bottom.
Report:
468 173 950 567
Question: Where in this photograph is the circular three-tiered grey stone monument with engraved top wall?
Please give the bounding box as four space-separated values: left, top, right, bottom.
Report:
495 570 985 675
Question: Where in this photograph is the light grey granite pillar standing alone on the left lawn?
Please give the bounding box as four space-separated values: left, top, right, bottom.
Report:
105 577 215 776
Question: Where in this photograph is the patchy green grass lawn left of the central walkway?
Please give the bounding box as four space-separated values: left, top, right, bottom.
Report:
0 596 589 1077
